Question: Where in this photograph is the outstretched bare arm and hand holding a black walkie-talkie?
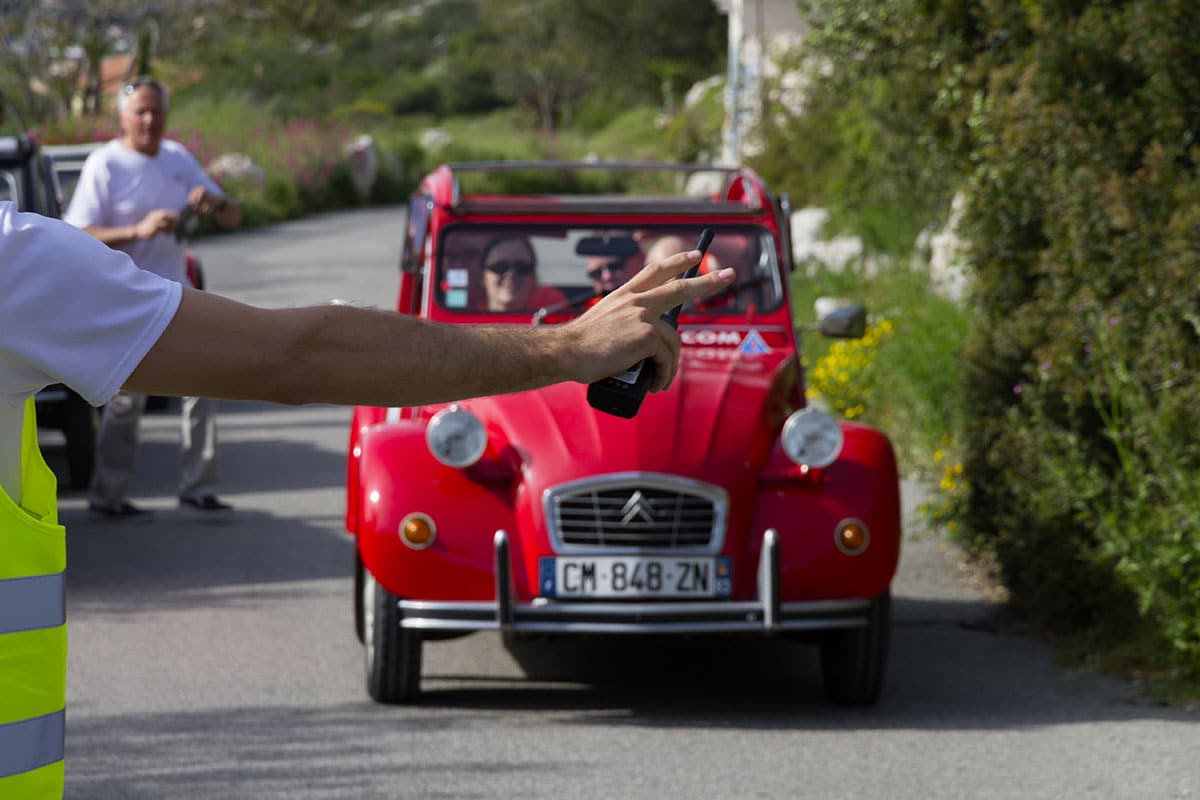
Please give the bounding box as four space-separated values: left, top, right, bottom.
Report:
126 251 733 405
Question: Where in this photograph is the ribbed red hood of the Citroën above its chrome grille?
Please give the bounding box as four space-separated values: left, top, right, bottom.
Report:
464 348 797 486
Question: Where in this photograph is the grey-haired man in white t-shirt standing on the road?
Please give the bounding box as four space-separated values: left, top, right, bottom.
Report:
64 78 241 521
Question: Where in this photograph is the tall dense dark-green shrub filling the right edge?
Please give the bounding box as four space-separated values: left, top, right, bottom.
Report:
964 0 1200 669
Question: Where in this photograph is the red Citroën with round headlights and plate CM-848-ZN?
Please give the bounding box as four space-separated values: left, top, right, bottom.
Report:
346 162 900 704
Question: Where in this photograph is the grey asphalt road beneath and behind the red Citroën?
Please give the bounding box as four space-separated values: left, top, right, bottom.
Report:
50 209 1200 800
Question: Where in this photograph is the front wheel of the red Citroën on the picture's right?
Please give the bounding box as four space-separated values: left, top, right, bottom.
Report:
821 589 892 705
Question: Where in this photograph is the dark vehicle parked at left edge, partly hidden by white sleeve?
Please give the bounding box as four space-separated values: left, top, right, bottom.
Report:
0 134 96 488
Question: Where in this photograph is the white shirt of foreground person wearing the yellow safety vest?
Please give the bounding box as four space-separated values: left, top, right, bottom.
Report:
0 203 182 503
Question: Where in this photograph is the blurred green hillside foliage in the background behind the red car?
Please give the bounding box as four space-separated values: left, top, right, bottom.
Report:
0 0 725 224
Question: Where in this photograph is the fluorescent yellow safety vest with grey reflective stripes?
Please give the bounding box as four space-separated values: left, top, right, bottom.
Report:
0 398 67 800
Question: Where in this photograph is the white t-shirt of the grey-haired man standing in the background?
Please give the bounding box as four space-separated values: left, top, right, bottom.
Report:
62 139 224 283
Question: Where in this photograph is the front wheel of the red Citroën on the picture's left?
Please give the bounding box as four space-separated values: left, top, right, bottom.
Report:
362 569 421 703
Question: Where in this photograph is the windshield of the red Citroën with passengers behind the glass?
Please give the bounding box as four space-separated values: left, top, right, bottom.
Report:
436 225 782 317
